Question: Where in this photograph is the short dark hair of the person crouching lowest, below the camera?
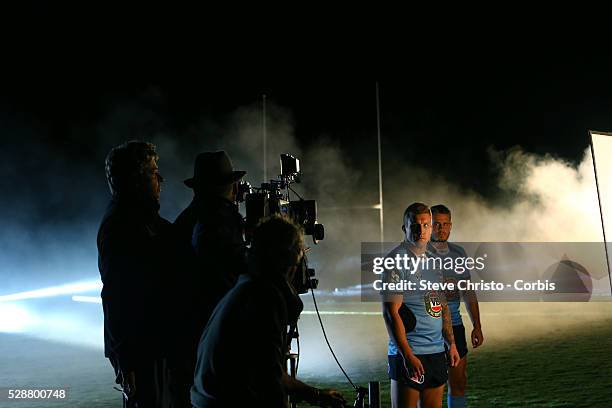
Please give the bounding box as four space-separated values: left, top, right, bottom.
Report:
249 214 304 276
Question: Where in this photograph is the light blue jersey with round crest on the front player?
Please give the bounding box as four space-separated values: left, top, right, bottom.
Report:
385 243 444 356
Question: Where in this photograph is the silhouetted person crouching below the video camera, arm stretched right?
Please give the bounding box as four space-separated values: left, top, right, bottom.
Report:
191 215 344 408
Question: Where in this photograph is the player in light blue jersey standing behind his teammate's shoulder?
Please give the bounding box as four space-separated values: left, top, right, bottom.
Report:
430 204 484 408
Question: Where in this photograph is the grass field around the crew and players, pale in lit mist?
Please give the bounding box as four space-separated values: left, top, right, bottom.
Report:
0 302 612 408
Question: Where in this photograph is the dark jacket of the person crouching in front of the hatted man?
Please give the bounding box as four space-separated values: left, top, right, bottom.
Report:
191 275 288 408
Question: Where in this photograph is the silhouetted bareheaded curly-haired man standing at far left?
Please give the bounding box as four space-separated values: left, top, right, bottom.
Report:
97 141 170 408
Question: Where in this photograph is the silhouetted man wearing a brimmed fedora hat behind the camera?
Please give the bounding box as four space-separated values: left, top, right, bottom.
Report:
170 151 246 406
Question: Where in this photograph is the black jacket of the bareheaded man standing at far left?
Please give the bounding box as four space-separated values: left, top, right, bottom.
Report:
97 200 172 371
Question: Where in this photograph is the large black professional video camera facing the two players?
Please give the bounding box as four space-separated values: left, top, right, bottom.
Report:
238 154 325 294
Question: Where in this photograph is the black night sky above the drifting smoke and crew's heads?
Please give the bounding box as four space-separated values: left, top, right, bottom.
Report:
0 10 612 233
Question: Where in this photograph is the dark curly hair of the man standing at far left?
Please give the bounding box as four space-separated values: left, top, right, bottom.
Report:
104 140 159 197
